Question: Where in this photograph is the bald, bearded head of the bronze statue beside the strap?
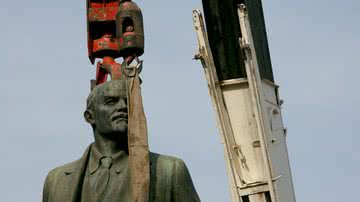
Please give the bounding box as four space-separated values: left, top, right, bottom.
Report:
84 80 128 138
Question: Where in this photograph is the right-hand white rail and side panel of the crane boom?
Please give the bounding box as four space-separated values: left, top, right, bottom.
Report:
238 4 295 202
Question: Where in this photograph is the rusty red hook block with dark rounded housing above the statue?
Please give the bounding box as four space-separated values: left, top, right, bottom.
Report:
87 0 144 64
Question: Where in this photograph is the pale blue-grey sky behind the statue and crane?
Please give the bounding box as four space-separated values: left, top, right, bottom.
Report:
0 0 360 202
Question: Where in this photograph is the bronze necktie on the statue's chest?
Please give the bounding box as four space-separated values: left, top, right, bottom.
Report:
93 157 112 202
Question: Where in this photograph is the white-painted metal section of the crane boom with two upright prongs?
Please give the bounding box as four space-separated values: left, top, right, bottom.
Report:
193 2 295 202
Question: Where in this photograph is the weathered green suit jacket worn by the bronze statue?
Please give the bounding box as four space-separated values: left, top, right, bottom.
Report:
43 145 200 202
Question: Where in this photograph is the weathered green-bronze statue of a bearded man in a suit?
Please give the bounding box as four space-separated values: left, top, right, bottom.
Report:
43 80 200 202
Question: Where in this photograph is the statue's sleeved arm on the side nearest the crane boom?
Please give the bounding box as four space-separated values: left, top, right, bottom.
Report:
172 160 200 202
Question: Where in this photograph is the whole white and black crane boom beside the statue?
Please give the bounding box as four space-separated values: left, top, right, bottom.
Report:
193 0 295 202
